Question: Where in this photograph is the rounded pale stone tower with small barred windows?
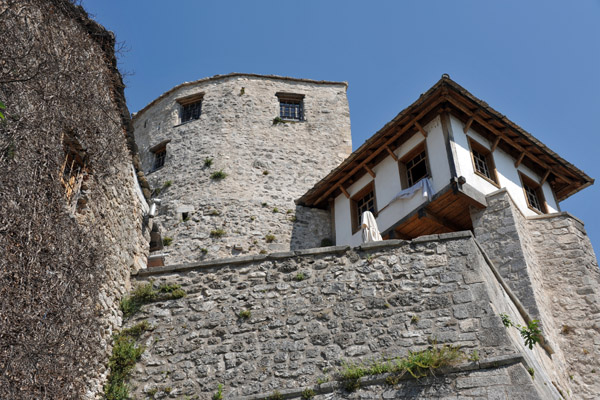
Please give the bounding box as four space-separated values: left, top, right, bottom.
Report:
134 75 352 264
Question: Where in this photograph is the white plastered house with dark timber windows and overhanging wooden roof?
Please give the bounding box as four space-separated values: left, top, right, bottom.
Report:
297 75 593 246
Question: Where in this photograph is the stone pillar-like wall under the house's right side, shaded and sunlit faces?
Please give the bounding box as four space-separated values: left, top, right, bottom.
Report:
473 190 600 399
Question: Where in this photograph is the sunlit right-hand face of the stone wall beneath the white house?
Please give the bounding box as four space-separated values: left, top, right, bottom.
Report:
527 213 600 399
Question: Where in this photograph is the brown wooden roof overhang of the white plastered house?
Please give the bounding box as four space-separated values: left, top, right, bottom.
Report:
296 75 594 208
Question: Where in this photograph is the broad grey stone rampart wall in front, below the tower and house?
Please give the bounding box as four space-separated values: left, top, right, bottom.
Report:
127 234 558 398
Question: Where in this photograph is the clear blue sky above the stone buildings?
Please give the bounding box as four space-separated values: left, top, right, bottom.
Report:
82 0 600 251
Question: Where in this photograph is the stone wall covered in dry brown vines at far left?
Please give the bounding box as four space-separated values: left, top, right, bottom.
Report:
0 0 148 399
